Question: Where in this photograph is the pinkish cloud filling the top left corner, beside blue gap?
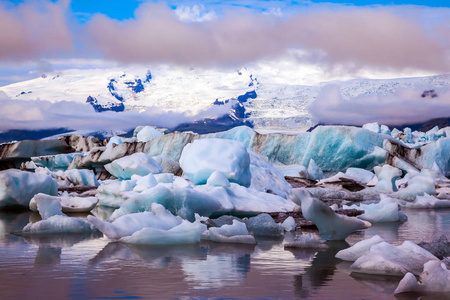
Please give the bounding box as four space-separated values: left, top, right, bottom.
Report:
0 0 73 60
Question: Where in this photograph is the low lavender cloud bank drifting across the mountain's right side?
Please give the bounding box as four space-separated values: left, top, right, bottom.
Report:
309 85 450 125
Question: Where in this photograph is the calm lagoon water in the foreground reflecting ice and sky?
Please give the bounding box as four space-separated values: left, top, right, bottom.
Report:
0 210 450 299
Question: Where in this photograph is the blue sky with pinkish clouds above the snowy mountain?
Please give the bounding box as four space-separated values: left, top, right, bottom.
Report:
0 0 450 131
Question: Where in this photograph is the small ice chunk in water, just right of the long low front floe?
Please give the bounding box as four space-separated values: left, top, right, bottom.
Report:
209 220 256 245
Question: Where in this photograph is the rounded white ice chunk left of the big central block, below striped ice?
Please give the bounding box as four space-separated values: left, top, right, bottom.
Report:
105 152 162 179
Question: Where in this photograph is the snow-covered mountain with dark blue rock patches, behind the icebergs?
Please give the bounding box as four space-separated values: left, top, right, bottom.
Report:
0 64 450 131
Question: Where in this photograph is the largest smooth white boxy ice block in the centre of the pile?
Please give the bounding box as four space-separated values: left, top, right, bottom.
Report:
180 139 251 186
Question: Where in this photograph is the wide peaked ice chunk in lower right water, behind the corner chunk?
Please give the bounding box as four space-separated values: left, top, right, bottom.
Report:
350 241 438 276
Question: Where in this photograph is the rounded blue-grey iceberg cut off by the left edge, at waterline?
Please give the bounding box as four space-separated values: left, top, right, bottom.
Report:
0 169 58 208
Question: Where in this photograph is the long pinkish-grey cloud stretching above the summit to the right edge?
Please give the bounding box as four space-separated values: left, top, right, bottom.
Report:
86 3 450 72
